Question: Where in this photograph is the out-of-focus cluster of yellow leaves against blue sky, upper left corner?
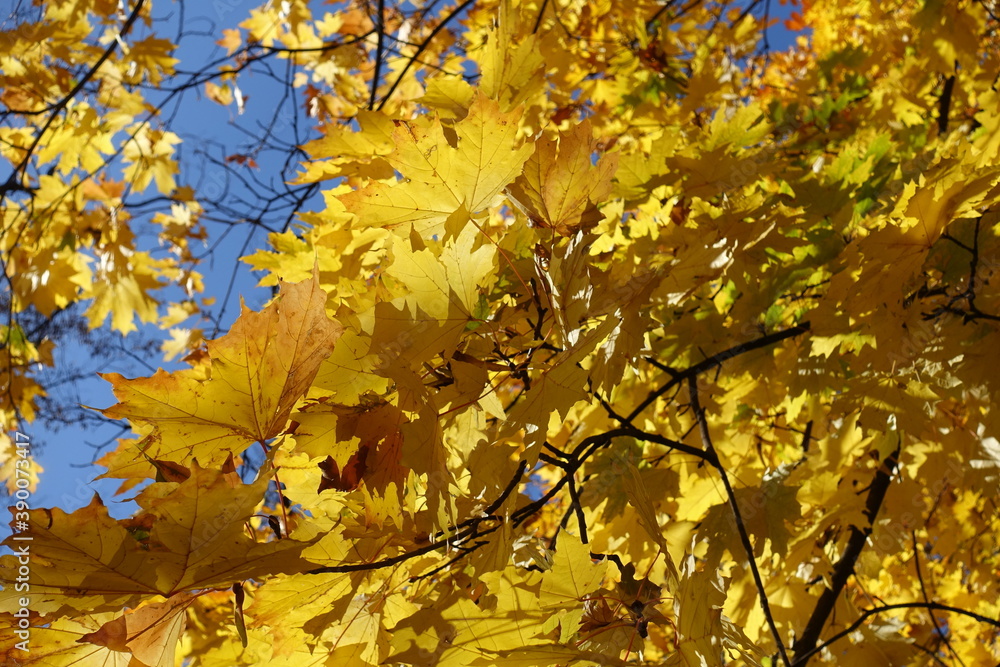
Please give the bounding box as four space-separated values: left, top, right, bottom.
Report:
0 1 204 448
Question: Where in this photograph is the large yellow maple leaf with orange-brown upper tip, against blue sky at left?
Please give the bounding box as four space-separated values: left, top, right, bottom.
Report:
103 276 343 465
